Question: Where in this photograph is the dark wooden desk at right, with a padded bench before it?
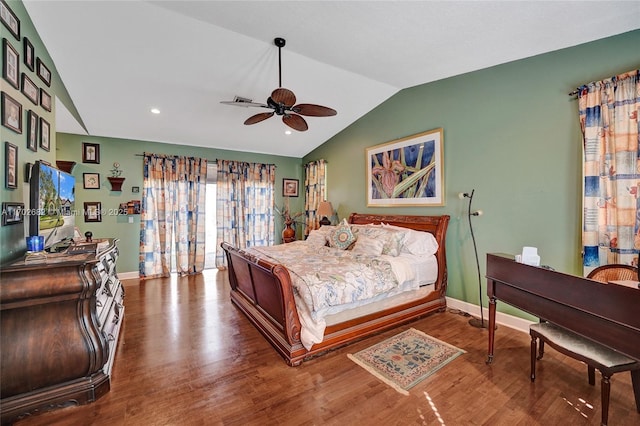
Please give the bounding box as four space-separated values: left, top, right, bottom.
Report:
487 253 640 364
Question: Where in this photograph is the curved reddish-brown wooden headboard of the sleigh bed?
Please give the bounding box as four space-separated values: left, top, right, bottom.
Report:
349 213 450 295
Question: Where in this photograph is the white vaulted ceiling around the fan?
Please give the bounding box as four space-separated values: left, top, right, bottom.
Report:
24 0 640 157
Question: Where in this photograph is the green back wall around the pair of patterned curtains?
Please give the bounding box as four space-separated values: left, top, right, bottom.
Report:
57 133 303 273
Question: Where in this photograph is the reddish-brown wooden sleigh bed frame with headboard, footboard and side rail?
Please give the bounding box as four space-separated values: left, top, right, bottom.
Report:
221 213 449 366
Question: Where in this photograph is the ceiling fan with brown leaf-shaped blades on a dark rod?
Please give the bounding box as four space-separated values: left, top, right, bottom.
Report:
221 37 337 132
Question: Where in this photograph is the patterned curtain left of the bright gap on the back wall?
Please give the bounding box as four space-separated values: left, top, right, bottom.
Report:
140 153 207 279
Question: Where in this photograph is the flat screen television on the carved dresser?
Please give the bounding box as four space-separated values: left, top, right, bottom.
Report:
29 161 76 250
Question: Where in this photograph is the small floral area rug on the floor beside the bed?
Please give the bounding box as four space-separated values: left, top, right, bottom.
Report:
347 328 466 395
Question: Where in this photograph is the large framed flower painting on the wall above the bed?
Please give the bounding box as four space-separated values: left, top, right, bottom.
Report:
365 128 444 207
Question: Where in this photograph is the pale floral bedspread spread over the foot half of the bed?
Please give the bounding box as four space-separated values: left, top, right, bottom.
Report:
245 241 399 320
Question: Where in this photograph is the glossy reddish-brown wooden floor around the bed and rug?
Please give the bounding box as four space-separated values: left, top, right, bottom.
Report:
18 271 640 426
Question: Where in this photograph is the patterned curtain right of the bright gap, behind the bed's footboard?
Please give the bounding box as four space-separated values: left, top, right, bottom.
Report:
216 160 276 269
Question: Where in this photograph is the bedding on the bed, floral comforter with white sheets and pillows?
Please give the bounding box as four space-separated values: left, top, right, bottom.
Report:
246 225 438 349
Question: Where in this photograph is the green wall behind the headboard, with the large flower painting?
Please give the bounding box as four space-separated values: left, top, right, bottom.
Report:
303 30 640 315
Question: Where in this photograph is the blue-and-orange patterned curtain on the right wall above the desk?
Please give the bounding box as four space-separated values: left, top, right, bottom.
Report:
578 70 640 276
